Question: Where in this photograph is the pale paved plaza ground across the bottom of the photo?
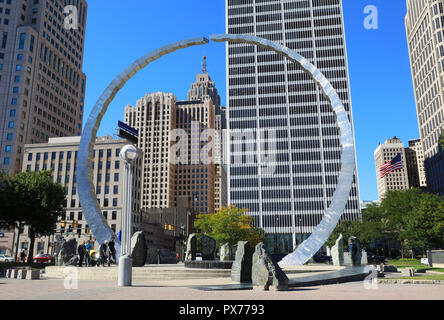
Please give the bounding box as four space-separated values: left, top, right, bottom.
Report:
0 278 444 301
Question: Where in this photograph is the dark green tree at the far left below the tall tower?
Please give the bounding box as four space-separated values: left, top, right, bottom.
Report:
0 171 65 263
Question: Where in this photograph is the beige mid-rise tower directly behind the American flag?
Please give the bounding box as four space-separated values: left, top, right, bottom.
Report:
374 137 410 200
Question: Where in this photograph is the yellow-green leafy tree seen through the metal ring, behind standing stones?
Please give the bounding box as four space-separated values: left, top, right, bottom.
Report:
195 206 265 246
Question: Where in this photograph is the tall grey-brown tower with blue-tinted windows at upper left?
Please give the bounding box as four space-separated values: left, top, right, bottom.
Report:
0 0 87 173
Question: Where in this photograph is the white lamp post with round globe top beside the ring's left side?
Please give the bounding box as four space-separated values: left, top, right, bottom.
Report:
117 145 139 287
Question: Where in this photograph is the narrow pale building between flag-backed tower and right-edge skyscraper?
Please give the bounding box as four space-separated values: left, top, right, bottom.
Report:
405 139 427 188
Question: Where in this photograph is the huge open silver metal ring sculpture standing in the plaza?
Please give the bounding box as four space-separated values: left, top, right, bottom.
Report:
77 34 355 266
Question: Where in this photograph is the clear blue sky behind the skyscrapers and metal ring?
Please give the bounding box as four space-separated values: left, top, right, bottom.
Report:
83 0 419 200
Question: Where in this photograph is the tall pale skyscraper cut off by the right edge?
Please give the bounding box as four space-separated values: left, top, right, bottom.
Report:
405 0 444 194
